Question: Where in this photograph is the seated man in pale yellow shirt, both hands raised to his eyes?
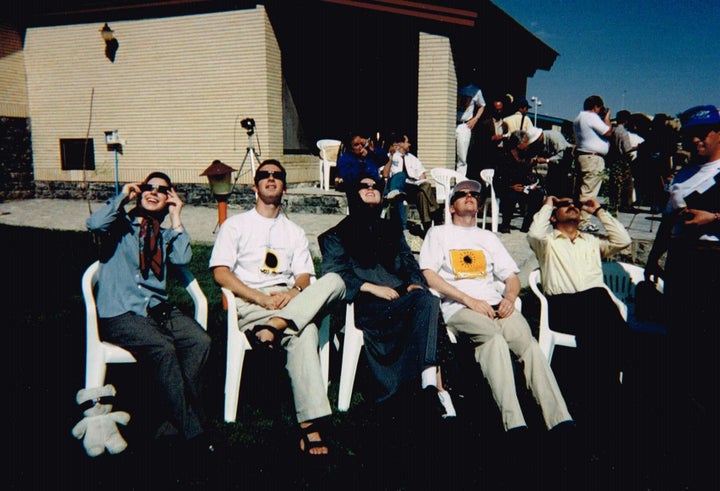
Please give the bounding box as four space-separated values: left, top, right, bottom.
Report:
527 196 631 472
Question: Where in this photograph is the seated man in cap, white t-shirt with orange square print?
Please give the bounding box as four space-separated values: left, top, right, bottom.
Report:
420 180 572 431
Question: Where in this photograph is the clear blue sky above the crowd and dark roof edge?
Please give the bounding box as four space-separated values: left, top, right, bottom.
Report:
493 0 720 119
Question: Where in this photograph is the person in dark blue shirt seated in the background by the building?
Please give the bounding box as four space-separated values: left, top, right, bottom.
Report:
336 133 391 189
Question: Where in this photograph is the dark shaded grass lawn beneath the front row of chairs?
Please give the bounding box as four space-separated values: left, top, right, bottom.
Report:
7 226 669 491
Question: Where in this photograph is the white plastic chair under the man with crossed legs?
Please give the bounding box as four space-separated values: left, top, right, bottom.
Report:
221 277 330 423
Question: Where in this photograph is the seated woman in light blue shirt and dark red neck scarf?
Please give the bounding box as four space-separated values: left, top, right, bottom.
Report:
86 172 210 449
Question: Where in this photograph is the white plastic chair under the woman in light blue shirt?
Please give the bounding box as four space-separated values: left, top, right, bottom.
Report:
82 261 208 388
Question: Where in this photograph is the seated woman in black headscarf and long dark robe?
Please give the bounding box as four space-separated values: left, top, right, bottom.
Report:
318 175 455 416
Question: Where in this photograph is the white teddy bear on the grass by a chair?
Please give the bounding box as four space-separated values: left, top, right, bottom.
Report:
72 384 130 457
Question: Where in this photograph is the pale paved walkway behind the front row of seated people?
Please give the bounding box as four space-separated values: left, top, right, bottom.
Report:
0 199 659 286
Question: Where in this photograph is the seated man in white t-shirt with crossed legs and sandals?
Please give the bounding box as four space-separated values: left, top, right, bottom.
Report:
210 160 345 455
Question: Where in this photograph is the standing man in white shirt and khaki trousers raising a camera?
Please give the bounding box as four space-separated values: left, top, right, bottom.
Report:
573 95 612 232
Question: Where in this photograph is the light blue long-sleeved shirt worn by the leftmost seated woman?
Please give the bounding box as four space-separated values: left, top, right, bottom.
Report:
86 193 192 318
